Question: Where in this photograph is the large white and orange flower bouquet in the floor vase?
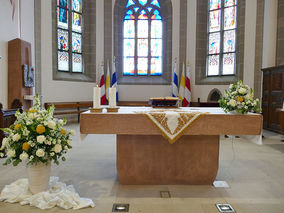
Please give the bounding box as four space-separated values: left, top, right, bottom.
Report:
0 95 74 166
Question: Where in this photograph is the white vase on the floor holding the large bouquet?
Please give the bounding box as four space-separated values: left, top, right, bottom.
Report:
28 162 50 194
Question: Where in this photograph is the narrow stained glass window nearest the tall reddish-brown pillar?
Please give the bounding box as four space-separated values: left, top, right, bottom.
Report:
56 0 83 73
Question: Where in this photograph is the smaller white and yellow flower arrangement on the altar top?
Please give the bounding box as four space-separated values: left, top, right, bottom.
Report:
219 80 261 114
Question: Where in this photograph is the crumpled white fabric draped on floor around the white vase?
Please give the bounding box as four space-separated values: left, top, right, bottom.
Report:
0 176 95 209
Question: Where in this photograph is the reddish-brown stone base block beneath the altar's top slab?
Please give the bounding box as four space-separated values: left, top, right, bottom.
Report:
117 135 219 185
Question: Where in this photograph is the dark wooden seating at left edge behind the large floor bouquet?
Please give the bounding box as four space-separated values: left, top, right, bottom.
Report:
0 103 23 156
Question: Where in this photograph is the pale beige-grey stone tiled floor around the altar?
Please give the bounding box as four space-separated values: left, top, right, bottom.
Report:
0 124 284 213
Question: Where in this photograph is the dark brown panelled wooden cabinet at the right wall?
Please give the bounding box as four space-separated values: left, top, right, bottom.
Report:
262 65 284 134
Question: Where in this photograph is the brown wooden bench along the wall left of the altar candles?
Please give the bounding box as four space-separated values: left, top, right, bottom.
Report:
44 101 93 122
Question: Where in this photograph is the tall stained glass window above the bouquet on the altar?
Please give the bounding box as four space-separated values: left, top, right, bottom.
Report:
207 0 237 76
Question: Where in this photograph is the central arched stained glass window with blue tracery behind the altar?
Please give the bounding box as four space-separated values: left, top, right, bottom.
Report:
123 0 163 76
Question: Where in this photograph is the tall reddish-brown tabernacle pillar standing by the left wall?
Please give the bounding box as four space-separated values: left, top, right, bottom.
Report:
8 38 33 109
